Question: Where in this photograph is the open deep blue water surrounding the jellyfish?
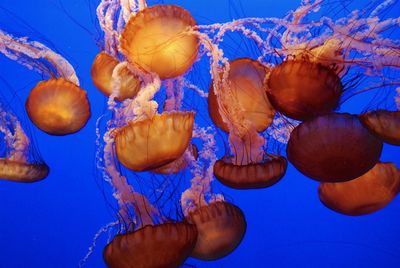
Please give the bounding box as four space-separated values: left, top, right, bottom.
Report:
0 0 400 268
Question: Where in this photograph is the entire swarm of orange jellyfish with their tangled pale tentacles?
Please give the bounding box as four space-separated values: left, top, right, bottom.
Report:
0 0 400 268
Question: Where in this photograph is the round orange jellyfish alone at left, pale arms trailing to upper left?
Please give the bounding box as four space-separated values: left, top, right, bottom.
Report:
0 30 90 135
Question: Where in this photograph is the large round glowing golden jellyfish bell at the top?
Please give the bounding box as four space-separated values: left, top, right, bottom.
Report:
120 5 199 79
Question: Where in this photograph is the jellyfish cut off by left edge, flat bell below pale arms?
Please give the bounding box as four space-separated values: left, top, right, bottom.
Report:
0 94 49 182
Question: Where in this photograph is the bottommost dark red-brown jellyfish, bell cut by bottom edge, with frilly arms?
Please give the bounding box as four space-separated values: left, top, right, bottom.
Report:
92 124 197 268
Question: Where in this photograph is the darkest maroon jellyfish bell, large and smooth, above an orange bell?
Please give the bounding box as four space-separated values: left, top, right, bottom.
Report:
286 113 383 182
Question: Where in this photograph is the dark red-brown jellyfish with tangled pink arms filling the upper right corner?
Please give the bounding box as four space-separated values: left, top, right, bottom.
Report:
265 0 400 120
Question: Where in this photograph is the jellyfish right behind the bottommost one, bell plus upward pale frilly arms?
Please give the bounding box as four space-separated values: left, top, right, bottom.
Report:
181 127 247 260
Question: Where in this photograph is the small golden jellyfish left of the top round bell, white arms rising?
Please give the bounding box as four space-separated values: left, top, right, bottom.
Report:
91 0 141 101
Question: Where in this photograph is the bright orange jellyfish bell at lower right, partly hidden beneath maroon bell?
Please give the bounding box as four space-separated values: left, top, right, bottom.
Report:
318 163 400 216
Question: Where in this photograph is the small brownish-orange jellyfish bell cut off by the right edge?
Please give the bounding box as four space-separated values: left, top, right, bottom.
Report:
360 110 400 145
